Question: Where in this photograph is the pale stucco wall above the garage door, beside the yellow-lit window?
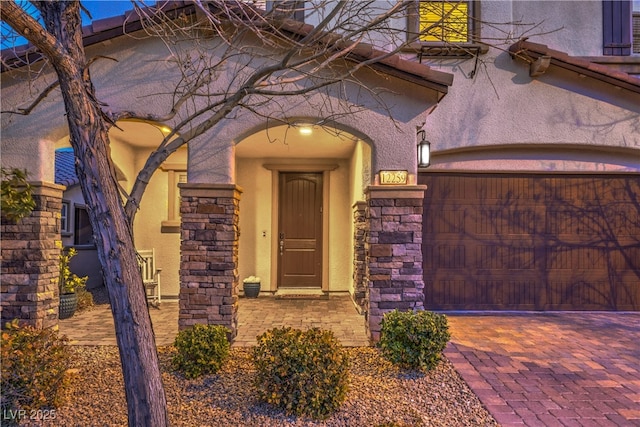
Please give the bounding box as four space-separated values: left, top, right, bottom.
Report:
426 1 640 171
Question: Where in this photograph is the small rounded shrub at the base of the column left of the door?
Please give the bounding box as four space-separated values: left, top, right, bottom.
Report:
172 324 231 378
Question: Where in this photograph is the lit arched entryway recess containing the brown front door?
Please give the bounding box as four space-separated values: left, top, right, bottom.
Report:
235 120 371 300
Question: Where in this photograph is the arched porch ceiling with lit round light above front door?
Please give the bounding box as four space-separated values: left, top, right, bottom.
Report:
236 126 358 159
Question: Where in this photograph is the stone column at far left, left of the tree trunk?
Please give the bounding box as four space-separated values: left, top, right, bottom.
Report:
0 182 65 329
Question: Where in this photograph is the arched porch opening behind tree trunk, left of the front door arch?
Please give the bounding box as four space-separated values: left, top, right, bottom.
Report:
55 121 187 300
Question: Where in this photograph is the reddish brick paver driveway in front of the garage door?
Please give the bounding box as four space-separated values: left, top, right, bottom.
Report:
445 312 640 426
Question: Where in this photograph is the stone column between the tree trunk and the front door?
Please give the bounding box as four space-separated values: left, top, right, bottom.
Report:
178 183 242 339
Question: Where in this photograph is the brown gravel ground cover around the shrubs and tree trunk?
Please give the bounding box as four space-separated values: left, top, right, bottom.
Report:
25 346 497 427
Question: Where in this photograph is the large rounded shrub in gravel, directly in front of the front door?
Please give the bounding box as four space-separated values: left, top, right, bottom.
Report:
253 328 349 419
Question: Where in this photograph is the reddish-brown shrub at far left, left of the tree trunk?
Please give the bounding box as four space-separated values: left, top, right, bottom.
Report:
0 320 71 413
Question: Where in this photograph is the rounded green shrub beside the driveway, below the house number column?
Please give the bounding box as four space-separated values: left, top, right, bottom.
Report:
378 310 451 371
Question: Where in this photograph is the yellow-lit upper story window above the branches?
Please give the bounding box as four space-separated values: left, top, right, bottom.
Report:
418 1 472 43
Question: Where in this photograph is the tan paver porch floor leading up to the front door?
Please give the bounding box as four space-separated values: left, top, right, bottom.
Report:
59 293 369 347
